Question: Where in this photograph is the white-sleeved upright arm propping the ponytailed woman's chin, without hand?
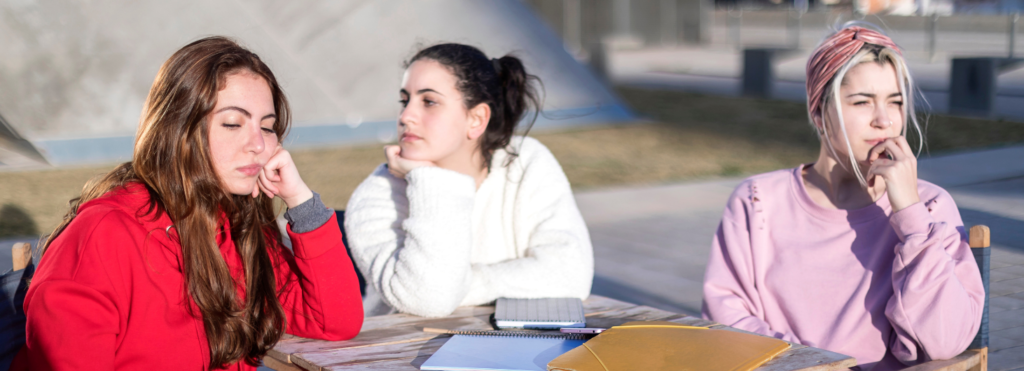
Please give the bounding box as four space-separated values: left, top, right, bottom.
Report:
346 167 475 317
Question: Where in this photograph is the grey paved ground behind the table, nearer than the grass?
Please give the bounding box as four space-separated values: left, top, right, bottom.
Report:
577 144 1024 370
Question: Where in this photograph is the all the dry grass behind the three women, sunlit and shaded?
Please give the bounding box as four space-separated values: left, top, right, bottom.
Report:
0 88 1024 237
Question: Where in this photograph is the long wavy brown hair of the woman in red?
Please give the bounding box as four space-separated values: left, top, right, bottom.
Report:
42 37 291 368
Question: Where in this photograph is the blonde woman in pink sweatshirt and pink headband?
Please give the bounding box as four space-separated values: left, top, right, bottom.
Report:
703 26 985 370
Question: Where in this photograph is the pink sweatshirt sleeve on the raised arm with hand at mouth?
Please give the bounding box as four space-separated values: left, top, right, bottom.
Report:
886 195 985 364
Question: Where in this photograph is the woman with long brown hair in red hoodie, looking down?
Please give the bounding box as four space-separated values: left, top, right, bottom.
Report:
13 37 362 370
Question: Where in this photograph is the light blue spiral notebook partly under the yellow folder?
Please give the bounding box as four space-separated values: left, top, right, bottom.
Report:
420 331 586 371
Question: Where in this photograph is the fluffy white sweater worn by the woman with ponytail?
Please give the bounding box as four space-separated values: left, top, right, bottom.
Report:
345 137 594 317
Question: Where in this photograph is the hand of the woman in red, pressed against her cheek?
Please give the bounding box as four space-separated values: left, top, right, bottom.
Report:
253 145 313 208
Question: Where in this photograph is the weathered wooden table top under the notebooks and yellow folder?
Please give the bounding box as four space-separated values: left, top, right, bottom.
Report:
263 295 857 371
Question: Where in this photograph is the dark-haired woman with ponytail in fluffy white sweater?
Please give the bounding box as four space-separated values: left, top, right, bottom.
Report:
345 44 594 317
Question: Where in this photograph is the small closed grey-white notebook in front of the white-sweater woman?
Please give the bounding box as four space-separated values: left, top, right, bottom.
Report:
495 297 587 329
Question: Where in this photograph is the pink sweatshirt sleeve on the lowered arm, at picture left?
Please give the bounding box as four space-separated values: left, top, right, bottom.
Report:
701 186 800 343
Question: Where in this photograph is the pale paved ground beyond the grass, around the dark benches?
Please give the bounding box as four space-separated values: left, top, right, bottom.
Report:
608 25 1024 121
